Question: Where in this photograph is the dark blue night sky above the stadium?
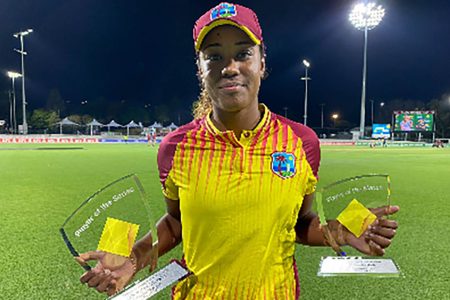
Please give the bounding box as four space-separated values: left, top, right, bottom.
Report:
0 0 450 126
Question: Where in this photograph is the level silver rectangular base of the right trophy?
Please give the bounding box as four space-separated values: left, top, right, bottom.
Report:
317 256 400 277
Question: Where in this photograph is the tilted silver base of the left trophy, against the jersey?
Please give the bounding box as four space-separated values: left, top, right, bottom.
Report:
109 261 189 300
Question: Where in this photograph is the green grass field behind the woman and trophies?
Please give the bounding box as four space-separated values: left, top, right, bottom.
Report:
0 144 450 300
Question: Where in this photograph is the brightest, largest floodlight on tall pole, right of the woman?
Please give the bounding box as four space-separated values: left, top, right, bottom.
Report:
349 2 384 137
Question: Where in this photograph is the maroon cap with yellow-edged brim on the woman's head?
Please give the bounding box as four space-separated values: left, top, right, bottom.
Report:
193 2 263 51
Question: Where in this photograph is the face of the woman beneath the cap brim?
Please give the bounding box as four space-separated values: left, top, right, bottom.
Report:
198 25 265 112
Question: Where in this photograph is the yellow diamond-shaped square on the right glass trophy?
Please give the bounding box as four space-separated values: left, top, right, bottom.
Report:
336 199 377 237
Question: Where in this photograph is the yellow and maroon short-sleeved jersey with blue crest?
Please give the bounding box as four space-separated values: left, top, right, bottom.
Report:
158 105 320 299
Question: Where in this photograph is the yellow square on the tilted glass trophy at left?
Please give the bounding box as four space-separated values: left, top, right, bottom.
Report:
97 218 139 257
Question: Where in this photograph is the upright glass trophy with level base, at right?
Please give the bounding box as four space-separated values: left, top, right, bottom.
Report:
316 174 400 277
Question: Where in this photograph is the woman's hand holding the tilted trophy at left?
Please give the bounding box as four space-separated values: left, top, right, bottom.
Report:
75 251 136 296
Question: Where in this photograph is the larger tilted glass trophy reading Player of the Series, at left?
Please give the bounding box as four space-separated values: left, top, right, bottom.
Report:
60 174 188 300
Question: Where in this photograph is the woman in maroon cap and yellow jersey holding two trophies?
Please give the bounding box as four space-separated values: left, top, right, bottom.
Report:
80 3 398 299
